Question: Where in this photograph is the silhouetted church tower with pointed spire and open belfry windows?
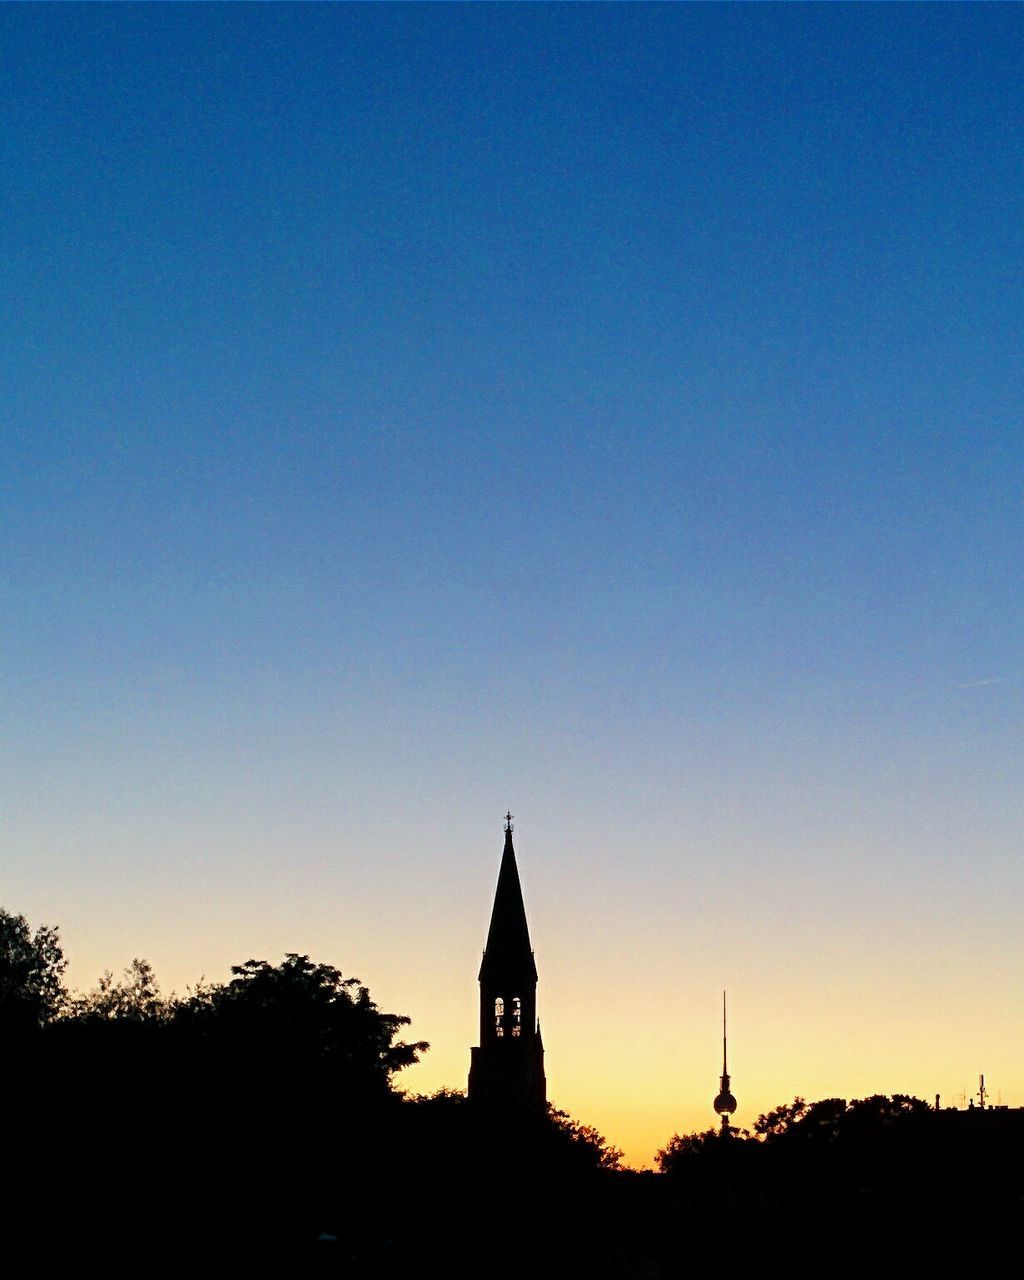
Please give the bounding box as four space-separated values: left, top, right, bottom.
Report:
470 813 547 1111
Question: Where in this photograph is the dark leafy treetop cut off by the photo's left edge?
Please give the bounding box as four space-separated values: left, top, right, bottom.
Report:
0 908 68 1033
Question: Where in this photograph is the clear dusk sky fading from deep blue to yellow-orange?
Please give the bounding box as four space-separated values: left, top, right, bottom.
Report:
0 5 1024 1166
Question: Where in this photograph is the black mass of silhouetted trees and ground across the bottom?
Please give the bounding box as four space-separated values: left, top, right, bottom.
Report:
12 913 1024 1280
